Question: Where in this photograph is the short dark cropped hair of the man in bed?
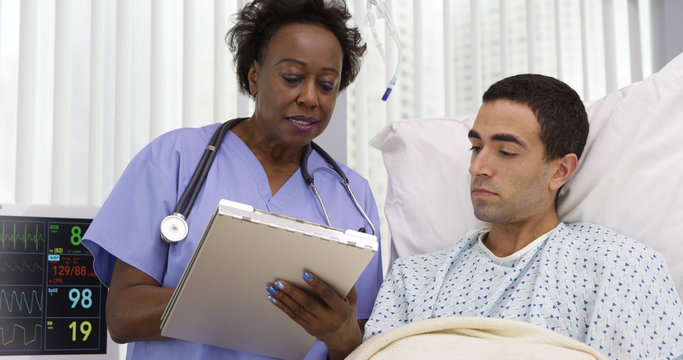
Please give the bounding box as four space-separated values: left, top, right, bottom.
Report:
482 74 588 160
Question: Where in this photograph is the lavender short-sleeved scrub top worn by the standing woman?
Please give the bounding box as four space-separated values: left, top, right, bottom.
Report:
84 124 382 359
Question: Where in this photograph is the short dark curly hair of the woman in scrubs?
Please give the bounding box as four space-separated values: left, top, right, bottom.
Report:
225 0 366 96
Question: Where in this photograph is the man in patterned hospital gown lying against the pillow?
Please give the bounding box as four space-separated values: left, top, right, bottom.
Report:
365 74 683 359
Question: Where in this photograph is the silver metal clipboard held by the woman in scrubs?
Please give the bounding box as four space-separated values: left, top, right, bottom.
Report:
161 200 378 359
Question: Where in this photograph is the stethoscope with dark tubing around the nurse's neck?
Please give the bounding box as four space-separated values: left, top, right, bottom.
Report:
161 118 376 244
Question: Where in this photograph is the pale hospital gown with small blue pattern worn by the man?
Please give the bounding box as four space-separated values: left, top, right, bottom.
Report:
365 223 683 359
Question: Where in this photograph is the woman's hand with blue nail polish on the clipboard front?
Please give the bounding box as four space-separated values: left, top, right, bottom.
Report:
267 272 363 359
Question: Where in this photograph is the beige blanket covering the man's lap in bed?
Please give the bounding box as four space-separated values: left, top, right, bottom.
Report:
347 317 607 360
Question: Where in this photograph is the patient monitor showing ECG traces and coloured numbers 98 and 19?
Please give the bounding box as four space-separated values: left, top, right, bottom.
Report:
0 205 108 356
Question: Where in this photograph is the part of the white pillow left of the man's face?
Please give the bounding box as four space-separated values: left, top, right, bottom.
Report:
372 116 484 262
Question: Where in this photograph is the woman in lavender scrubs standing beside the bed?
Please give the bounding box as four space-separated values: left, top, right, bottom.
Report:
84 0 382 359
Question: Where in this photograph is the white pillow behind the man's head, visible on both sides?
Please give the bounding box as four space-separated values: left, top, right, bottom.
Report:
372 50 683 294
